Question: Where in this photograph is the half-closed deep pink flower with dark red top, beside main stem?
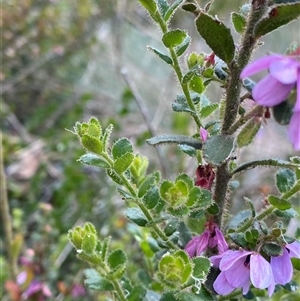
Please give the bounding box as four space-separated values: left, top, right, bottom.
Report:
184 222 228 257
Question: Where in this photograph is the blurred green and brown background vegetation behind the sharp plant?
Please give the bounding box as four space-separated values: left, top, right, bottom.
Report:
0 0 298 300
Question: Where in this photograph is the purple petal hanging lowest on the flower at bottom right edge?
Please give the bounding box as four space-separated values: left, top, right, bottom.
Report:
271 249 293 285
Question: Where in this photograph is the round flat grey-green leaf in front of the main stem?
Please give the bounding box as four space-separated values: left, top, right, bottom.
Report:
203 135 234 165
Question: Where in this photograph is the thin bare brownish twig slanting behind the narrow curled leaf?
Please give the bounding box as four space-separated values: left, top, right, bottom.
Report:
121 68 167 176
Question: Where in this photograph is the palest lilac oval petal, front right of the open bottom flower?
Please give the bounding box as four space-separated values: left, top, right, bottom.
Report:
250 253 273 289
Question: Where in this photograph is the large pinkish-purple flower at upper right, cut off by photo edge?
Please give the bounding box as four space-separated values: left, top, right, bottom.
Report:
240 54 300 150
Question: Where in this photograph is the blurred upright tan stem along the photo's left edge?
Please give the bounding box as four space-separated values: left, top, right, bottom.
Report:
0 131 17 280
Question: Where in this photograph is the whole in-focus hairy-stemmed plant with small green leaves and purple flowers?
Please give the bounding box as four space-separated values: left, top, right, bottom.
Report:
69 0 300 301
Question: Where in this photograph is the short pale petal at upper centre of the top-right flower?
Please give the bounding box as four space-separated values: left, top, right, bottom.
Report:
269 57 300 84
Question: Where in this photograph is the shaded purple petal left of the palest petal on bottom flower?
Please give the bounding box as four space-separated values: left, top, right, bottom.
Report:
224 258 250 295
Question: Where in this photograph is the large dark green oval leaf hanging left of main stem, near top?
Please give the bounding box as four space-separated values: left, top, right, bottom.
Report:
196 12 235 64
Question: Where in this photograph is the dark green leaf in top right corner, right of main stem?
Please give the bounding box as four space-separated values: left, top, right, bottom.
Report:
254 3 300 39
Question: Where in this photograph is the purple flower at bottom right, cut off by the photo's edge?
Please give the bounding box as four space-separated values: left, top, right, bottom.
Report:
271 241 300 285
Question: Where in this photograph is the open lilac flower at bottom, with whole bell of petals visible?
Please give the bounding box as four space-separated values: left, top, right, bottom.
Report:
210 250 275 296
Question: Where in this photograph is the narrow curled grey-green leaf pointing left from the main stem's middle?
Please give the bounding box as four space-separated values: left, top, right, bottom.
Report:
146 135 202 149
